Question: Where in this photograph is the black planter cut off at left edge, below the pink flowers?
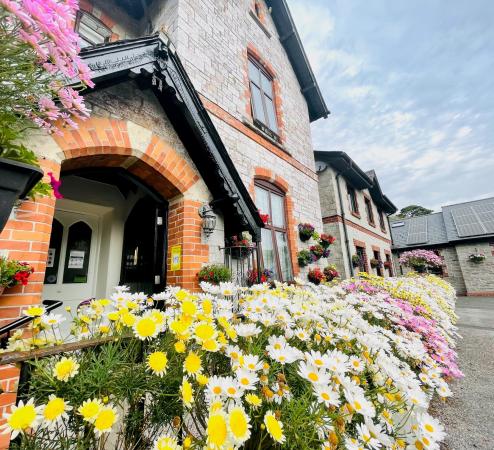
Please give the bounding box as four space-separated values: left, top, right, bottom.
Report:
0 158 43 232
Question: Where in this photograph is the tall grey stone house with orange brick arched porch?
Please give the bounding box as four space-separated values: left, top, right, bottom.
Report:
0 0 329 440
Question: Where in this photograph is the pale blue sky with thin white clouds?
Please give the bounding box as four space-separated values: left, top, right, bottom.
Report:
288 0 494 211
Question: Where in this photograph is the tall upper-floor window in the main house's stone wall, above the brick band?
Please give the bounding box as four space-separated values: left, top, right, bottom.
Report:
249 57 278 135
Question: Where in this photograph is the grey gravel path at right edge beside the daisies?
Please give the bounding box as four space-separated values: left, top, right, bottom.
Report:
432 297 494 450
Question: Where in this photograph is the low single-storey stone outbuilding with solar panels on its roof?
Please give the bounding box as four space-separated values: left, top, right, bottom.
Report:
391 198 494 296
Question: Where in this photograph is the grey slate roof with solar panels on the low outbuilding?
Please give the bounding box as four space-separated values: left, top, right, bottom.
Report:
391 197 494 249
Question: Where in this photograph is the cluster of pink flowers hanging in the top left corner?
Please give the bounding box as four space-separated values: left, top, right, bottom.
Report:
0 0 94 132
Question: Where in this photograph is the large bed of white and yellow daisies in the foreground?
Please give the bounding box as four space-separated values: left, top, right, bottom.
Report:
4 275 462 450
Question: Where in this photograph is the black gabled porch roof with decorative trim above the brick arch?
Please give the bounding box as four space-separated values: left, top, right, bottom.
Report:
80 34 263 240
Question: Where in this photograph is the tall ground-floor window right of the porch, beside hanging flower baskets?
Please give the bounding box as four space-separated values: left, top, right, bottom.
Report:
255 180 293 281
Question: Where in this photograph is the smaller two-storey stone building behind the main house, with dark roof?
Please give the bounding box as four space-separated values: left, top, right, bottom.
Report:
315 151 396 278
